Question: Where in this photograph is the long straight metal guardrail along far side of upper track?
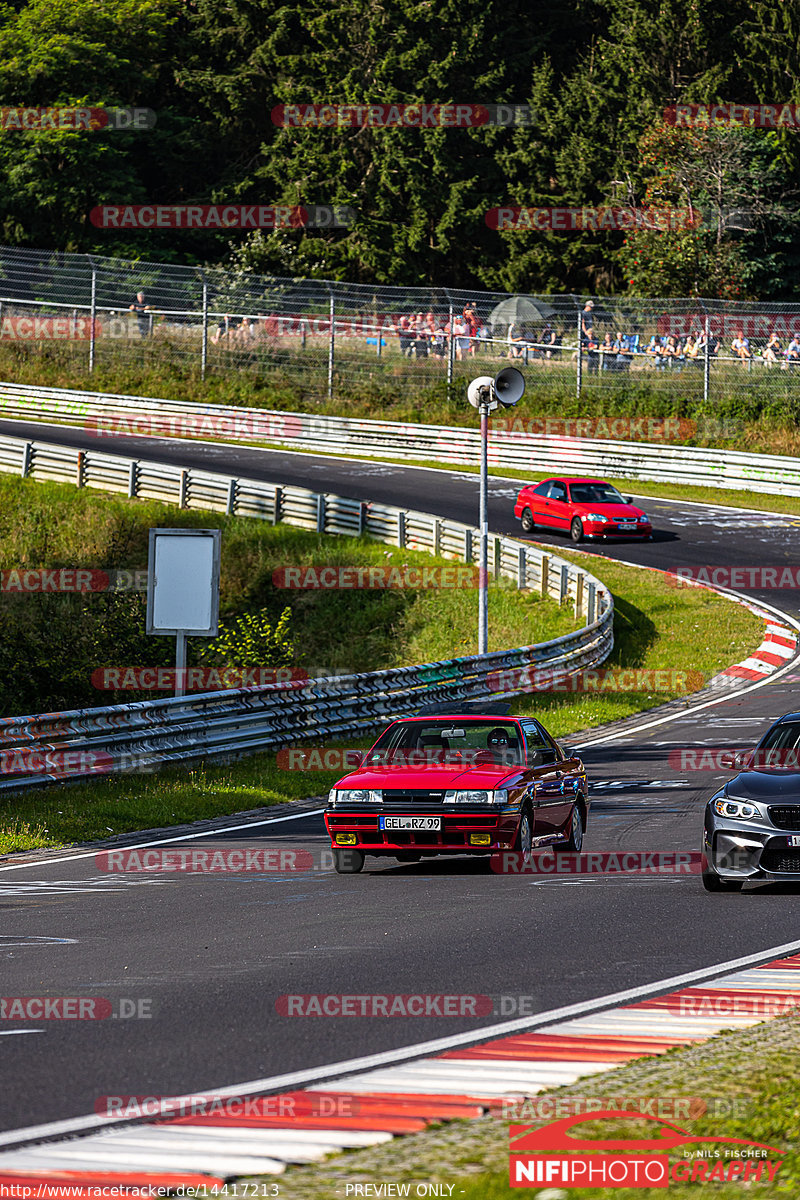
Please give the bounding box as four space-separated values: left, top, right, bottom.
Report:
0 383 800 496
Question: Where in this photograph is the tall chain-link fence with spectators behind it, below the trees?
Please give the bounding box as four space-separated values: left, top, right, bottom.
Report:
0 247 800 402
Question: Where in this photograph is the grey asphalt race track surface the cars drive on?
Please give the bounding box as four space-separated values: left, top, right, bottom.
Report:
0 421 800 1141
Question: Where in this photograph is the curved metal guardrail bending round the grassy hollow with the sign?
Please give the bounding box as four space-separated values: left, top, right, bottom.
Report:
0 437 614 791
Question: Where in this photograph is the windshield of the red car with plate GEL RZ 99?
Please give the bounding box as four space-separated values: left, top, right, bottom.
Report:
363 718 523 767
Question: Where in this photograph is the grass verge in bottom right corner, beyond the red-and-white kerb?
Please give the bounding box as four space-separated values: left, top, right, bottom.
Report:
261 1008 800 1200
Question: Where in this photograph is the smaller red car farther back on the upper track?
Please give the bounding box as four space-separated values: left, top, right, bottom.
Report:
513 479 652 541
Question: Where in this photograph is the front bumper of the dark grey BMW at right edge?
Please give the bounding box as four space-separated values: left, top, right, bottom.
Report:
703 815 800 883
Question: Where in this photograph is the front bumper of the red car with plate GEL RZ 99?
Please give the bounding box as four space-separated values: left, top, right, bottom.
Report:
325 808 519 856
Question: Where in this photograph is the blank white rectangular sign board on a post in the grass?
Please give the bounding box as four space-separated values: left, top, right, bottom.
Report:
148 529 222 637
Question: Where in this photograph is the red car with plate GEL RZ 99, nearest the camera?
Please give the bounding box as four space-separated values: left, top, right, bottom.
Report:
325 704 589 874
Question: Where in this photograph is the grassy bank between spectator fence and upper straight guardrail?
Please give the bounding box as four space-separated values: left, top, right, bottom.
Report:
0 340 800 455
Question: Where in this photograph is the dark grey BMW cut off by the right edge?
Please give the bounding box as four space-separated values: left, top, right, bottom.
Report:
702 713 800 892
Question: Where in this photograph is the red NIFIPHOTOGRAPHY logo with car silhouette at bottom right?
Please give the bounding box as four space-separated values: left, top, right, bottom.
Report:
509 1109 786 1188
